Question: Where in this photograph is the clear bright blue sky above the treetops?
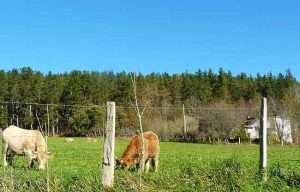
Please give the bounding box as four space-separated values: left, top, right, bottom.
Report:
0 0 300 80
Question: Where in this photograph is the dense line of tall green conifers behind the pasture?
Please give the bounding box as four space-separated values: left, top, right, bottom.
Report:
0 67 299 140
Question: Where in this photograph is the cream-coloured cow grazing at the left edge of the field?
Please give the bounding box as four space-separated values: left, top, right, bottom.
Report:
2 125 49 170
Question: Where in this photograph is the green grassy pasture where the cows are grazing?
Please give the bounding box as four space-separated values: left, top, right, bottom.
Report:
0 138 300 192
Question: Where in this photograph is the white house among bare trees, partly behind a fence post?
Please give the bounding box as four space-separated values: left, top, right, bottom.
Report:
245 116 293 144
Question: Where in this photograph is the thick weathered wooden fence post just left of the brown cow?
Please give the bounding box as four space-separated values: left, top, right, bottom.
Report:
102 102 116 188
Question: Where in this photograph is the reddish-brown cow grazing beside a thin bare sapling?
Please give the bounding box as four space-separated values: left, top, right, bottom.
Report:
117 131 160 172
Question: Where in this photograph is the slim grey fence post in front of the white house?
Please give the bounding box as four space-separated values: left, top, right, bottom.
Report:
259 97 268 181
